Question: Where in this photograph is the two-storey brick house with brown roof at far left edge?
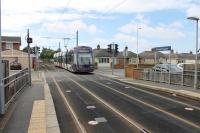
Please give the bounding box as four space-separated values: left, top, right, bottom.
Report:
1 36 21 51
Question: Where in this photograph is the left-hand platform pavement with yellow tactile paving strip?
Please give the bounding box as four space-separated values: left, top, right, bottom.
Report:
0 72 60 133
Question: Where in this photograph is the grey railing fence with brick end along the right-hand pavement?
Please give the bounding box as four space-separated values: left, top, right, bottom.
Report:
127 69 200 88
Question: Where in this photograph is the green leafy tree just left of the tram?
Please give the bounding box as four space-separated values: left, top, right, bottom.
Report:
40 48 55 60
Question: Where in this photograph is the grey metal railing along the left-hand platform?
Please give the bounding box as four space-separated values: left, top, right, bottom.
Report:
0 68 29 114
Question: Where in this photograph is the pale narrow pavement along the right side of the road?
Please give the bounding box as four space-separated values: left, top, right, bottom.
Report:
94 68 200 100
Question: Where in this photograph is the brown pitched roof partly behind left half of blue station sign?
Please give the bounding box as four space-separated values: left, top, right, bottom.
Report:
139 51 166 59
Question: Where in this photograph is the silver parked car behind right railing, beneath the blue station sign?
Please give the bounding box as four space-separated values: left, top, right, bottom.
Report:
152 64 183 73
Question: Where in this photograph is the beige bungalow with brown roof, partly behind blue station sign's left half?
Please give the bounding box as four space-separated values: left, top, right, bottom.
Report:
139 51 167 65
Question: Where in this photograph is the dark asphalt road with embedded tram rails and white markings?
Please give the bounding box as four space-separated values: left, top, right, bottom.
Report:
43 65 200 133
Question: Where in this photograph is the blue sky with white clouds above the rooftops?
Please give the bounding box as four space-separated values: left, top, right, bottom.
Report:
1 0 200 53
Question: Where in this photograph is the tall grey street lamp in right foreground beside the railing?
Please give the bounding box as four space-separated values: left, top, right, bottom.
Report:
187 17 199 89
